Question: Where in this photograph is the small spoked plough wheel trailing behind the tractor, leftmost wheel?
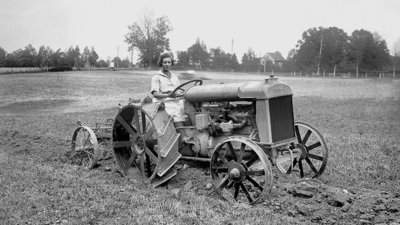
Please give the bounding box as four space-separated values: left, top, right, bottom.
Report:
69 125 99 169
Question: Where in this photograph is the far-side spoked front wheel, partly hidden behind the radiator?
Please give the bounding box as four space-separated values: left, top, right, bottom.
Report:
277 122 328 178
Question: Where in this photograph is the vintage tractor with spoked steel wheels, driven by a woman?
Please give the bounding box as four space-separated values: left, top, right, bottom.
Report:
111 76 328 204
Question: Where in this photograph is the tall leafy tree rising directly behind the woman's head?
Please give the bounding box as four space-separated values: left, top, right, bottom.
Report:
125 13 172 67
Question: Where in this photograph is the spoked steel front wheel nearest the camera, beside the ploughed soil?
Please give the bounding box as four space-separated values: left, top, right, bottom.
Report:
210 136 273 204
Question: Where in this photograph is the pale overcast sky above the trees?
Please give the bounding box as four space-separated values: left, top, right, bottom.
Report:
0 0 400 60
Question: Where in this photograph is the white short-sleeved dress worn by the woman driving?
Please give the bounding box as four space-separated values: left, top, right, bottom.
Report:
150 71 185 122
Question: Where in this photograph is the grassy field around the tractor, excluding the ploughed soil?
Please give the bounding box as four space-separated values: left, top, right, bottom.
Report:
0 71 400 224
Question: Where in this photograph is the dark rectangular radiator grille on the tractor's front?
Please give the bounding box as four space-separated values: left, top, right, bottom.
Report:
269 96 295 143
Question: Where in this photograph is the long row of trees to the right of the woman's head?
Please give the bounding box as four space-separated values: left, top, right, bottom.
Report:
177 27 400 74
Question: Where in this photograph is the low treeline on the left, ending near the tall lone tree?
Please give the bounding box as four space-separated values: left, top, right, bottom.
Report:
0 44 131 70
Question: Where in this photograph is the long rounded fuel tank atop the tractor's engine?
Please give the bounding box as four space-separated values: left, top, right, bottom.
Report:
184 77 293 102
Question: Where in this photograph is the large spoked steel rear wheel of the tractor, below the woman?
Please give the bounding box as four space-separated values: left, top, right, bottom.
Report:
112 105 160 183
